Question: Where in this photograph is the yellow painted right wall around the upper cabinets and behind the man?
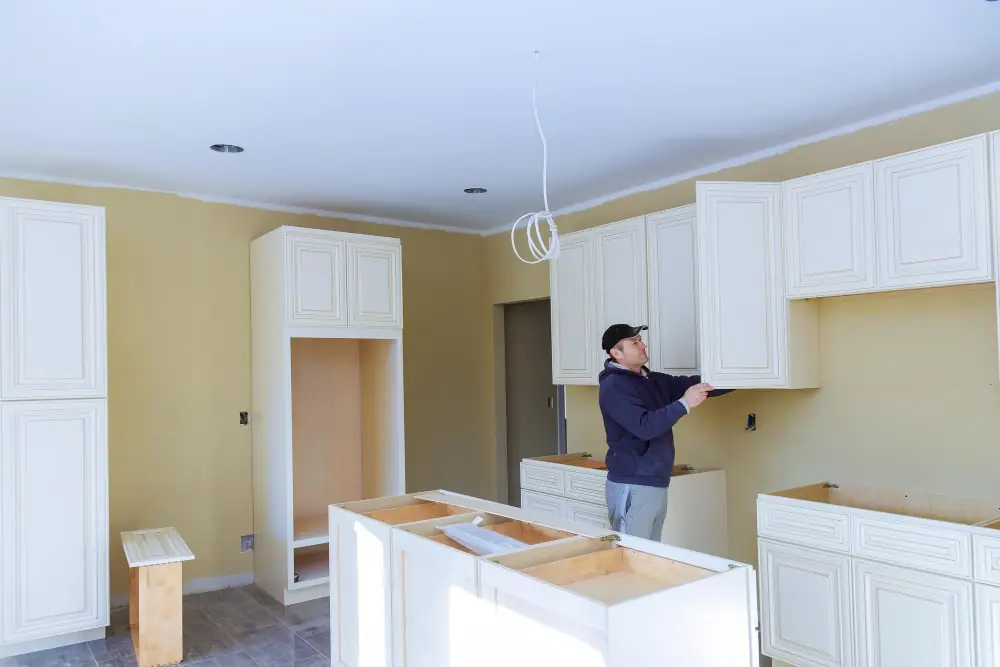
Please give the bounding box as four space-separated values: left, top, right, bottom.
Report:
487 87 1000 584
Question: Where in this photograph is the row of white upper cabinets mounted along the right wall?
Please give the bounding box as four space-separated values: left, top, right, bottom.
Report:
549 131 1000 389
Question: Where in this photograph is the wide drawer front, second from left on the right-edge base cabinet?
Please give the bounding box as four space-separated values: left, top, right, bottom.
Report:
851 516 972 577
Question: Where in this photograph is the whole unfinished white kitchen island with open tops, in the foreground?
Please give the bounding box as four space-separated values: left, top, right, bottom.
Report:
329 491 758 667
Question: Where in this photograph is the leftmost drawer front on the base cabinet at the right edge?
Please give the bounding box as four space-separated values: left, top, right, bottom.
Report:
757 500 851 553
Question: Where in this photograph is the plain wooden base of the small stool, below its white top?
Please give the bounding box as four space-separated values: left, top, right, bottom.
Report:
129 563 184 667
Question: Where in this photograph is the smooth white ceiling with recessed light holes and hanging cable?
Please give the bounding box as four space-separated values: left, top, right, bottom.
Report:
0 0 1000 235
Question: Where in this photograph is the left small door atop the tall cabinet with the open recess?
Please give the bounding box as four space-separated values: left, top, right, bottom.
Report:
285 234 347 327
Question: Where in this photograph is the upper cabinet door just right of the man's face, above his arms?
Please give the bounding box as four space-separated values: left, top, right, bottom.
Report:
646 204 698 375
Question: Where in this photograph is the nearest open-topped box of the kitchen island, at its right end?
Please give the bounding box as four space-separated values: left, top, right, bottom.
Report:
480 535 759 667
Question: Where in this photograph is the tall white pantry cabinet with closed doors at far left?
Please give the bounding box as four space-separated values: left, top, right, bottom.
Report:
0 197 109 657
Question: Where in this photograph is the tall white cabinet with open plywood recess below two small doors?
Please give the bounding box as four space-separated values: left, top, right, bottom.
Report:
251 227 405 604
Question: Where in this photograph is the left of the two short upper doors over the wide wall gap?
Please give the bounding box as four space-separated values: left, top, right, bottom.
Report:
782 162 875 298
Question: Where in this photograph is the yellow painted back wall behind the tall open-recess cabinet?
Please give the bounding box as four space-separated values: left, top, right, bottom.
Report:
0 179 493 596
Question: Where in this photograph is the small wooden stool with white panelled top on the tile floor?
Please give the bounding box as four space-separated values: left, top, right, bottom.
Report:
122 528 194 667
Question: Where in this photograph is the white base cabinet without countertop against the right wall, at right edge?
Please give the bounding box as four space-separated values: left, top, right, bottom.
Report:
757 483 1000 667
